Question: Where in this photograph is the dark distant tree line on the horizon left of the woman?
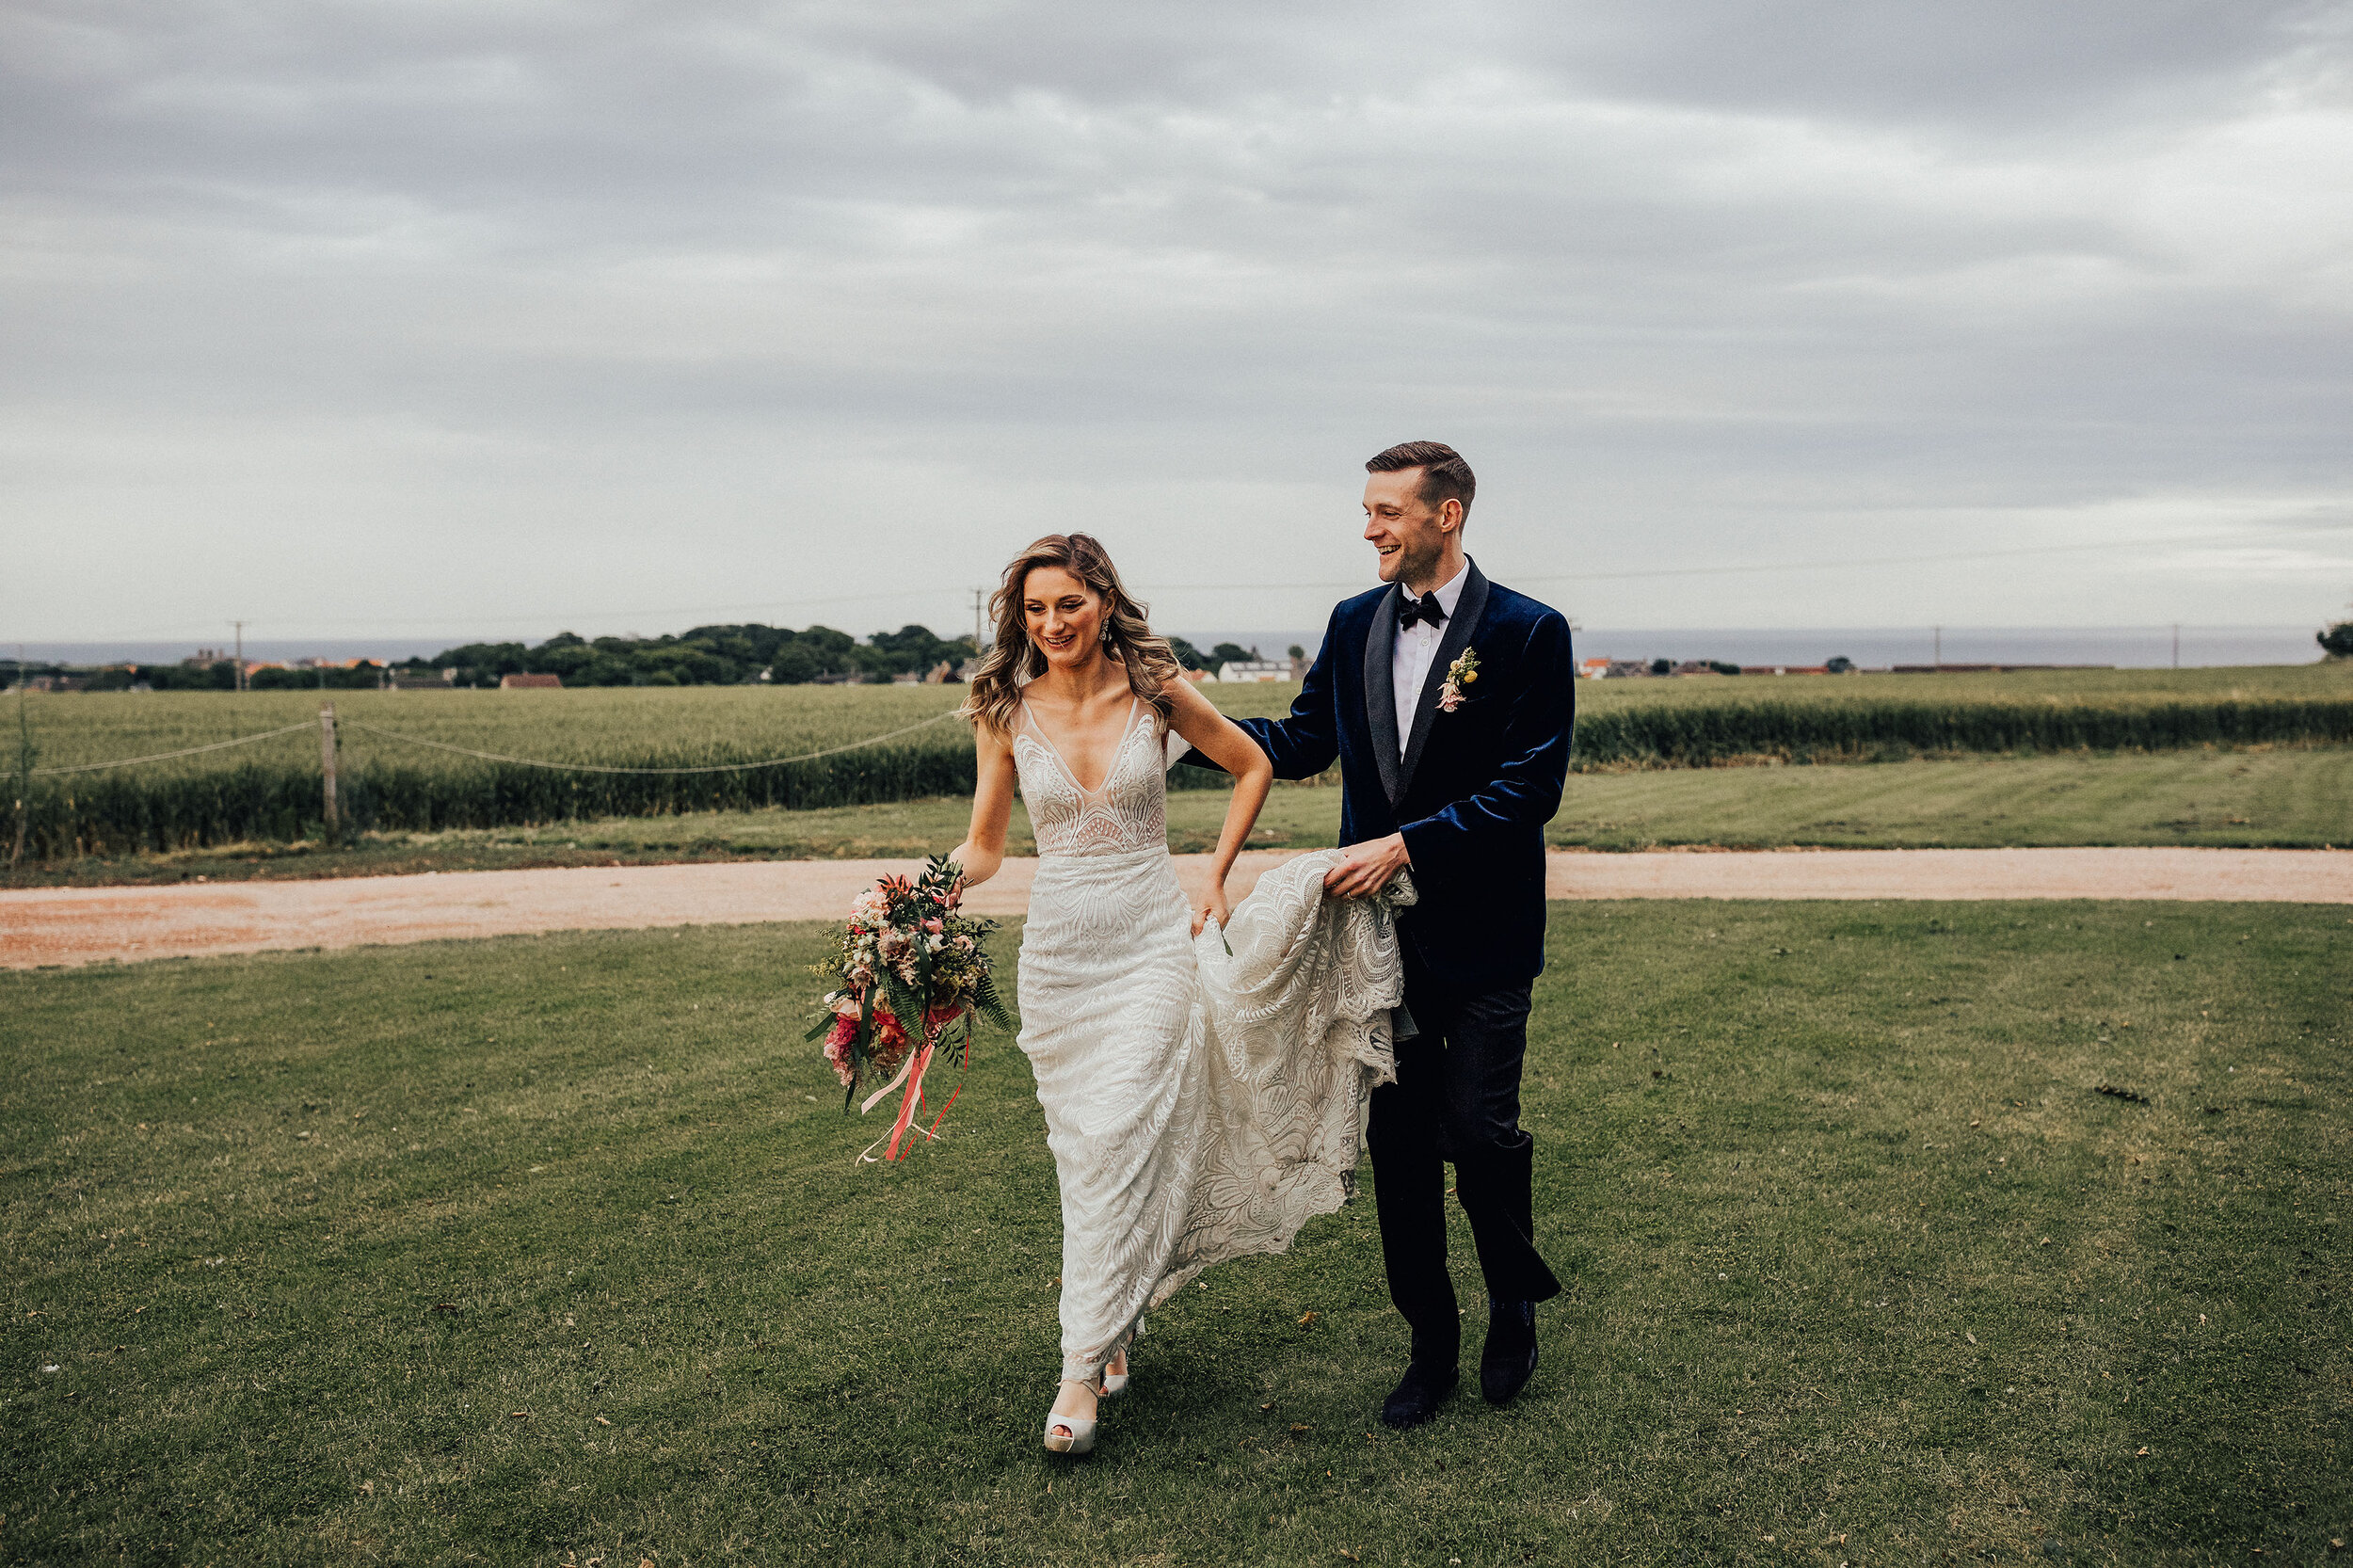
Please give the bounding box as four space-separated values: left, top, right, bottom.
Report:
414 624 972 685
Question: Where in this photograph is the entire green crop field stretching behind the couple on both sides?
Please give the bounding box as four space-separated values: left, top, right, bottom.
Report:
19 664 2353 859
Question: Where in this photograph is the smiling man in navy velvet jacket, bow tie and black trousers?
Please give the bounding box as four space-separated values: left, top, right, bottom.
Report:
1189 440 1577 1427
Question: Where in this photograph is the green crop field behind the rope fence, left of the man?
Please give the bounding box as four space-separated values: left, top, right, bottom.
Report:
9 685 1289 859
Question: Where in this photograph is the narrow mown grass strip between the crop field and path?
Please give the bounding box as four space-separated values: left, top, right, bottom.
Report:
19 748 2353 886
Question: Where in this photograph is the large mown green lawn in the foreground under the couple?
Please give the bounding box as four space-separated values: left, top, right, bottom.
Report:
0 904 2353 1568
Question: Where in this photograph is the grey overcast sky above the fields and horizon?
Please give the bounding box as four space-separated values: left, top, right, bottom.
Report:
0 0 2353 640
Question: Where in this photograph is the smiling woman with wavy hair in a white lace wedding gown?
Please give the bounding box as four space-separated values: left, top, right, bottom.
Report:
953 535 1412 1452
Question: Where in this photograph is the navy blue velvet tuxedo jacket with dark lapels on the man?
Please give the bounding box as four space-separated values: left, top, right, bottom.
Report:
1186 563 1577 989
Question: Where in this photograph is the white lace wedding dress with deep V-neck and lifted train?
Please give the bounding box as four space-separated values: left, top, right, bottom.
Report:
1015 701 1412 1380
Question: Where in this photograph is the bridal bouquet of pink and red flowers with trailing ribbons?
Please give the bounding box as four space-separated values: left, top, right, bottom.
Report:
809 855 1012 1160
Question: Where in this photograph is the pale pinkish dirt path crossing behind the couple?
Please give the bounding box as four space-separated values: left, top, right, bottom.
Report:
0 850 2353 970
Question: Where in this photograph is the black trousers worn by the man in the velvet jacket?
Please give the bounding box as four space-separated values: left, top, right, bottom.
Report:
1368 939 1561 1366
